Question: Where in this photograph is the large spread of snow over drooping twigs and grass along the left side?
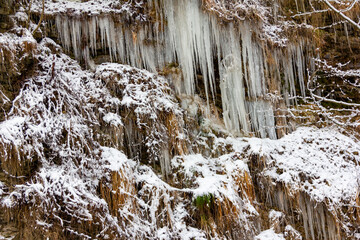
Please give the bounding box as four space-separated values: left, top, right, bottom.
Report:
0 31 148 238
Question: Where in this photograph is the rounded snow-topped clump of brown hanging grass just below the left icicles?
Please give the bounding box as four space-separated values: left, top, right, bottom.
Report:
95 64 186 175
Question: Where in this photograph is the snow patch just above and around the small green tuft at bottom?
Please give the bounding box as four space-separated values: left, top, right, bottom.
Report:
172 153 259 234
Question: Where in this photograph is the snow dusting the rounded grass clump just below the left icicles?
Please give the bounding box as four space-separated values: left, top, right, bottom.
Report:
95 63 183 175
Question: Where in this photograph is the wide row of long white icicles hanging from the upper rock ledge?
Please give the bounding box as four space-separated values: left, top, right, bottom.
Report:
52 0 305 138
